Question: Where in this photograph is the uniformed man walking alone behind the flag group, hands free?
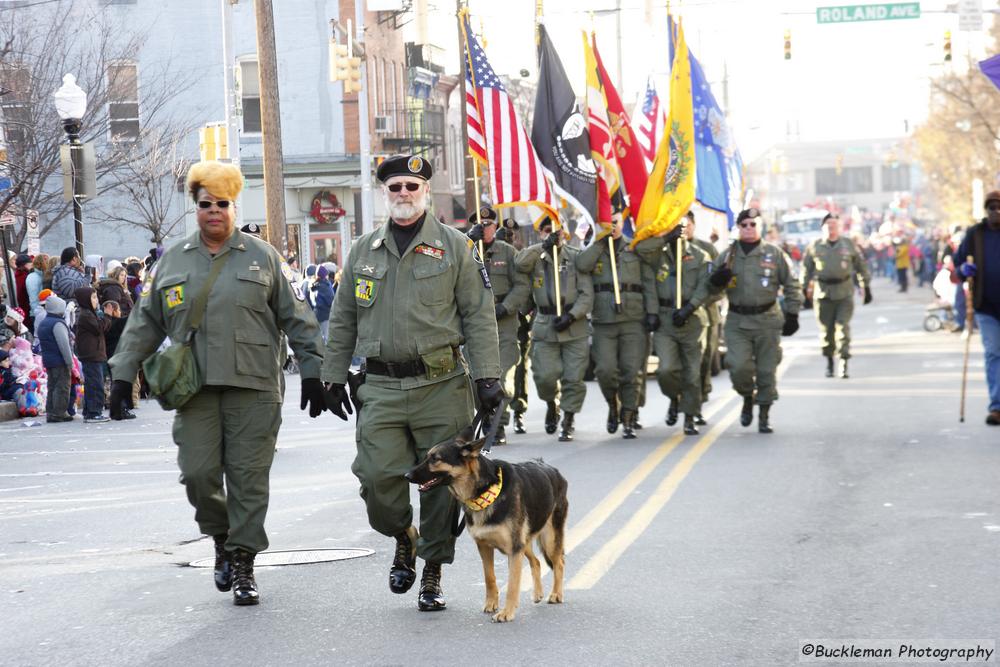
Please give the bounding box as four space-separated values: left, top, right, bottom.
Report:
802 213 872 379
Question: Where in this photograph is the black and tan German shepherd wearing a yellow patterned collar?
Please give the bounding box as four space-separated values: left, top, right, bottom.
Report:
406 429 569 623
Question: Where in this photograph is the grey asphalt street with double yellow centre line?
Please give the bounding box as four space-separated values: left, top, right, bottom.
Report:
0 280 1000 666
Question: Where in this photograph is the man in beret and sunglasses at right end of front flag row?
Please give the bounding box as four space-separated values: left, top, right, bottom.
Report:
709 208 802 433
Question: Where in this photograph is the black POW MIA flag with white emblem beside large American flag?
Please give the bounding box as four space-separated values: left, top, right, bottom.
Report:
531 26 597 230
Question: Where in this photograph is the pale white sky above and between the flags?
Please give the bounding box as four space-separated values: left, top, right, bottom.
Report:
406 0 997 158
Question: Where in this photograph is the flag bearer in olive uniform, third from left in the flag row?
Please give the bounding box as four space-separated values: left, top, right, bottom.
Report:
576 215 656 439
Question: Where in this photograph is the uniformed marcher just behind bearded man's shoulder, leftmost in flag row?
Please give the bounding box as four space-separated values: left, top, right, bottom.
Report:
469 206 528 445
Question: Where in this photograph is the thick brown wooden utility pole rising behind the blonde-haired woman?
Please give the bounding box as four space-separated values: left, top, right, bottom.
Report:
254 0 288 257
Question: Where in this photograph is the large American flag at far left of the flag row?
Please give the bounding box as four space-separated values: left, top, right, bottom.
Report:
462 10 559 224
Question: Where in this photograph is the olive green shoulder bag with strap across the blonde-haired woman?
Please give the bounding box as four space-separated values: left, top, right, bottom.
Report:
142 252 231 410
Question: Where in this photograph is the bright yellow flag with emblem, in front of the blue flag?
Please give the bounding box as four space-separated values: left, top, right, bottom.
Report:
633 22 695 244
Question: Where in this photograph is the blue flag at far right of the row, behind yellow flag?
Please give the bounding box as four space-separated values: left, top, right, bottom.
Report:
669 17 743 227
